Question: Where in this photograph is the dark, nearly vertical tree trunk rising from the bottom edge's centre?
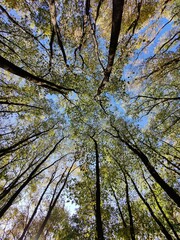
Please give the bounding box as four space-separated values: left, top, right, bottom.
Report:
91 137 104 240
